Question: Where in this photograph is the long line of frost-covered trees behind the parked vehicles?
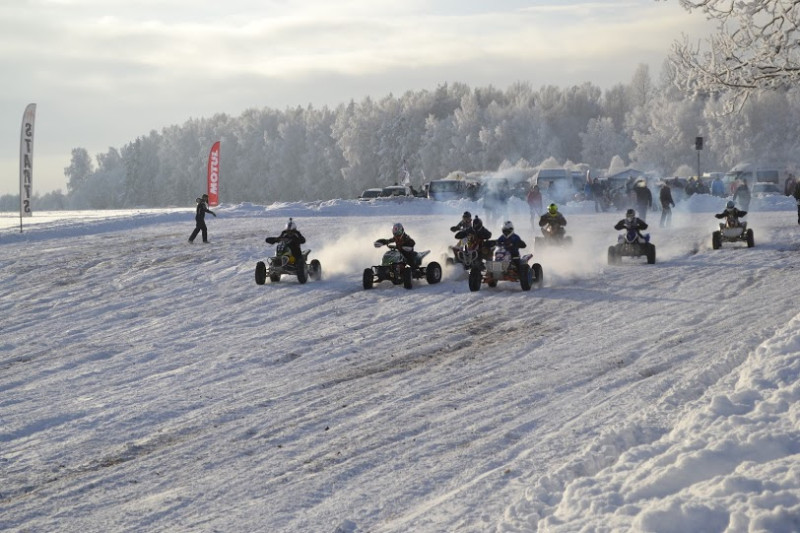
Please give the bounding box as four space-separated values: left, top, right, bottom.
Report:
0 61 800 210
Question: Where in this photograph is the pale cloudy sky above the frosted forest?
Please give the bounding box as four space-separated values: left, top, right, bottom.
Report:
0 0 709 194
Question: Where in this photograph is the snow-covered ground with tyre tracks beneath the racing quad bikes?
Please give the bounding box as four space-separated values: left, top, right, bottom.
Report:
0 196 800 533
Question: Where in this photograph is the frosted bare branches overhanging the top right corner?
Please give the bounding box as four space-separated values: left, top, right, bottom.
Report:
670 0 800 106
